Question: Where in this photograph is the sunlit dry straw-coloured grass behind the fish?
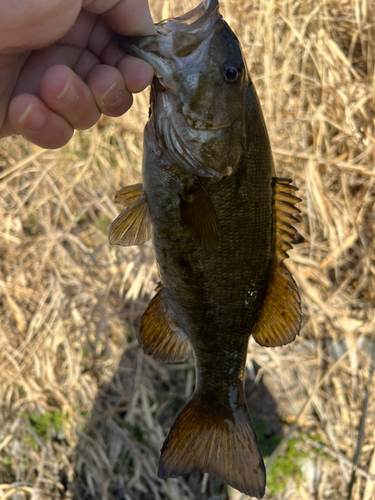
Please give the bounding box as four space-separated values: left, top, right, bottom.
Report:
0 0 375 500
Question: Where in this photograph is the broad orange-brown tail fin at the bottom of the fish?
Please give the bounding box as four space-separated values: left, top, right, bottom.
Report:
158 393 266 498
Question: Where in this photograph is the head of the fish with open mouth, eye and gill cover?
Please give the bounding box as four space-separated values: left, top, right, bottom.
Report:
123 0 249 178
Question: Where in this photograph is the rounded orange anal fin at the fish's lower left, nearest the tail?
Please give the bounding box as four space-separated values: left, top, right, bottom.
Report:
138 287 190 363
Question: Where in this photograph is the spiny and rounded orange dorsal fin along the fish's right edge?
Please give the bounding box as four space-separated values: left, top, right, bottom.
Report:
252 178 302 347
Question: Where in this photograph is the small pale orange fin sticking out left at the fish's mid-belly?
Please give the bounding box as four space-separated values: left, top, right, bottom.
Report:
108 184 151 247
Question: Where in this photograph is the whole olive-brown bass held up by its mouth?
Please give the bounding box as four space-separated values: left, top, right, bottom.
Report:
109 0 301 498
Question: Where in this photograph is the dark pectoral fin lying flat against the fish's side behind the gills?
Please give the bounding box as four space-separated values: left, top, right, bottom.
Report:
181 180 220 252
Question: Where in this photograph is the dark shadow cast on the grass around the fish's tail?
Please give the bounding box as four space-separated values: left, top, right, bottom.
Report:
67 342 282 500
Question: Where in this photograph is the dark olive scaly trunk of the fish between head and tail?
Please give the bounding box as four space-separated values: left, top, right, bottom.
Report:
142 88 273 386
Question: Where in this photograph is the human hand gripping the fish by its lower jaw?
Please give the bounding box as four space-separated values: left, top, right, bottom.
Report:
0 0 155 149
